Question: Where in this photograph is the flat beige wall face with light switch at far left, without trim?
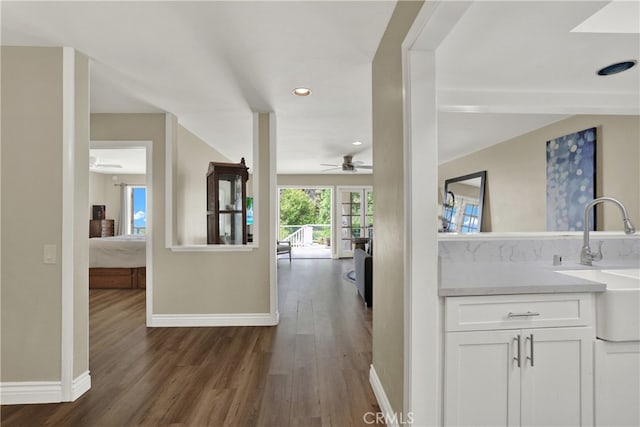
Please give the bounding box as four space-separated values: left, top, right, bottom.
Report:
0 47 62 382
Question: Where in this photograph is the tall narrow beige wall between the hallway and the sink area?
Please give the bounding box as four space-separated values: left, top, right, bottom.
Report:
372 1 422 414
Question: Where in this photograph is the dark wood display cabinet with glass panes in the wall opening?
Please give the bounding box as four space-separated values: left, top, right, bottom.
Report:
207 157 249 245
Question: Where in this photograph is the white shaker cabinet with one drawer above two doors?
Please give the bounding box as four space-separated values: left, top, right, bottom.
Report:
444 294 595 426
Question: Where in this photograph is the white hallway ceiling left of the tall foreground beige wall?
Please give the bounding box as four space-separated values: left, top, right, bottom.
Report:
1 1 395 173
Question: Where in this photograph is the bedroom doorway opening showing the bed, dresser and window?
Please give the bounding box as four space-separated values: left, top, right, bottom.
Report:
89 141 151 291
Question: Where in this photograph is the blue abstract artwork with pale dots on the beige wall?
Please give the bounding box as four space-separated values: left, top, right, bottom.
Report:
547 128 596 231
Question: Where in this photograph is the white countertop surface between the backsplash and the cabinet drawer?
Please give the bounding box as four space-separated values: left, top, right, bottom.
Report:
438 262 625 296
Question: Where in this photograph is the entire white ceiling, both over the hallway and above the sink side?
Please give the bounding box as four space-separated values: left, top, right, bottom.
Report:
0 0 640 173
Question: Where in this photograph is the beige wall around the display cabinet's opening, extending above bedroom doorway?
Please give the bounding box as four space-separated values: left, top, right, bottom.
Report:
91 114 275 320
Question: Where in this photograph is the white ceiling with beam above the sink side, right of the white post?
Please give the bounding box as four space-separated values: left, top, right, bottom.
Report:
432 0 640 163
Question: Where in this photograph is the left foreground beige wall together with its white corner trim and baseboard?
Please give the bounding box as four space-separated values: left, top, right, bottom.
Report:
0 47 89 392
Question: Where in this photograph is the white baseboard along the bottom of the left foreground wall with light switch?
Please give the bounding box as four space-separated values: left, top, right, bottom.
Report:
0 371 91 405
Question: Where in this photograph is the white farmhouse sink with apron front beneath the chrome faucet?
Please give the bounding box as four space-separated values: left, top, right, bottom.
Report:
558 268 640 341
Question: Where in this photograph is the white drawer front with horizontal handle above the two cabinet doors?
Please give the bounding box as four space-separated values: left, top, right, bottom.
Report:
445 293 593 332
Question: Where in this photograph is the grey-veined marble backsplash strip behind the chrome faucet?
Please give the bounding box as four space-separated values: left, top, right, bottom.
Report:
438 234 640 264
